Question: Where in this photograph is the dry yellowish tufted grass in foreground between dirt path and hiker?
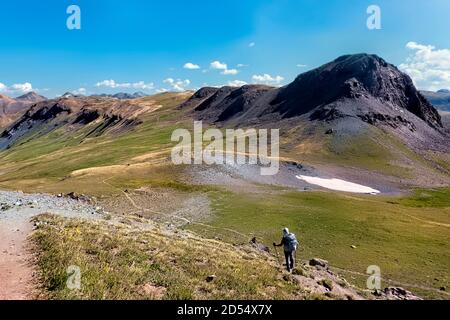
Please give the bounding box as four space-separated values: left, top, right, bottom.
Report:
32 215 298 300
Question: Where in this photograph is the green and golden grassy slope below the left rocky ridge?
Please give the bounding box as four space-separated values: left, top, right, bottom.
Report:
0 94 192 190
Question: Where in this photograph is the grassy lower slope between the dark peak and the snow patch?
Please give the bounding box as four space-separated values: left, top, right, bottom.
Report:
281 123 450 189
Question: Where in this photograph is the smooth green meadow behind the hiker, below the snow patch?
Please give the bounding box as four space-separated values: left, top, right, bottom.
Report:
189 189 450 299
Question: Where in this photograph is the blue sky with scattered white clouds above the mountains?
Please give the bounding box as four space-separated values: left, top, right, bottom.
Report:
0 0 450 97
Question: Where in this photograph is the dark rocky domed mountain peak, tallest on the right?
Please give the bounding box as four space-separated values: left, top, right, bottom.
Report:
271 54 442 127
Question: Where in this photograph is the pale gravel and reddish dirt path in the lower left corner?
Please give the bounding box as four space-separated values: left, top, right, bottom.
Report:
0 191 101 300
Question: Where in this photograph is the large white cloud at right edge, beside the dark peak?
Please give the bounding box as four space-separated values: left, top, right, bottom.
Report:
399 42 450 91
